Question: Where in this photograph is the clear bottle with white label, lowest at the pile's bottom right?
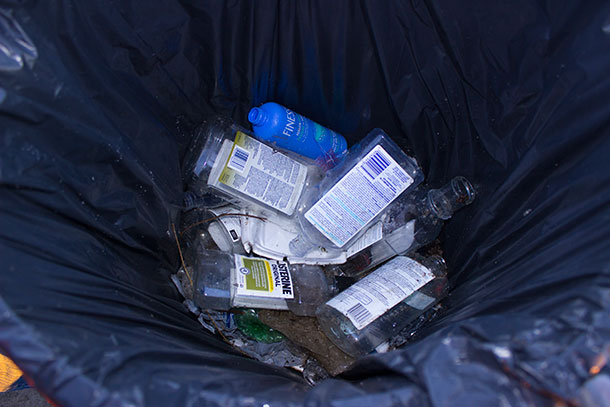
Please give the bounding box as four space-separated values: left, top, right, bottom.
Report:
316 255 448 357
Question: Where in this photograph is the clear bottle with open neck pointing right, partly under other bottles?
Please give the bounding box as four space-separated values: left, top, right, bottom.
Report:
325 176 476 276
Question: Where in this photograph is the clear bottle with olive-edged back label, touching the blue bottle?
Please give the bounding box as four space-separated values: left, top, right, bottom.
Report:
183 117 321 216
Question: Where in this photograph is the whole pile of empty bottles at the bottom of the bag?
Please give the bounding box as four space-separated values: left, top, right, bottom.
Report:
173 103 475 364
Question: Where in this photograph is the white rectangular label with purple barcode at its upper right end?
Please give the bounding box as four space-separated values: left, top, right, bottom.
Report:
305 145 413 247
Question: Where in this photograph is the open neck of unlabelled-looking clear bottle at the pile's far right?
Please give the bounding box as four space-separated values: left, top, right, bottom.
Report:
426 177 475 220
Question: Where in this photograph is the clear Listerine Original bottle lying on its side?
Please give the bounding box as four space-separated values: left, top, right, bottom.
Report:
193 250 336 316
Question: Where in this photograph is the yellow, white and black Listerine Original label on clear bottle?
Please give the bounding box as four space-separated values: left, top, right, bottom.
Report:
235 254 294 299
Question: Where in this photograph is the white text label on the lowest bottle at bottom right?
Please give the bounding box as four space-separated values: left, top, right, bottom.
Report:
326 256 434 329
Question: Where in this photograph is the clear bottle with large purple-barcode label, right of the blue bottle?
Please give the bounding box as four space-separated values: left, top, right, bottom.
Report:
291 129 424 256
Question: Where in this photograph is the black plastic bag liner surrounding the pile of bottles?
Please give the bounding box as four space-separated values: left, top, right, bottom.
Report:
0 0 610 407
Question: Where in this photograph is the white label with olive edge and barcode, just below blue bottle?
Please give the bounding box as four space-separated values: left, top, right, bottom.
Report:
208 131 307 215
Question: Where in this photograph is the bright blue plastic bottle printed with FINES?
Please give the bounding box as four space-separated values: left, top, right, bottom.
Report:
248 102 347 169
